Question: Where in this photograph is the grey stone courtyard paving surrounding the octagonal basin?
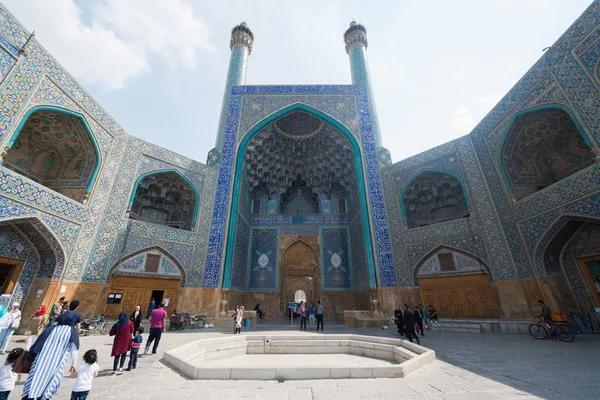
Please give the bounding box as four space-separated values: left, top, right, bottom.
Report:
5 325 600 400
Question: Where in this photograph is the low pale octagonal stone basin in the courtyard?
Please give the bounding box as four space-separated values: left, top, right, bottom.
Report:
163 334 435 380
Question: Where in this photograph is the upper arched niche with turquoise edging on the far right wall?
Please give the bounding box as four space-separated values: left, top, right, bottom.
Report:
498 105 596 200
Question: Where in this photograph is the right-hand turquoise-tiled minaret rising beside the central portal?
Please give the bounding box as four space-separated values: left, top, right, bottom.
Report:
344 21 382 149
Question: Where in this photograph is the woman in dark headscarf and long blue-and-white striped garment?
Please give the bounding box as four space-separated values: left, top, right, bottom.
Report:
22 300 81 399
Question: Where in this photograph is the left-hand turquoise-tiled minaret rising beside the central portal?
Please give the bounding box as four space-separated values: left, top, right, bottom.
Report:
215 22 254 148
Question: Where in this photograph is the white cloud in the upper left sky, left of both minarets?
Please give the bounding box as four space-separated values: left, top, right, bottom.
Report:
4 0 212 90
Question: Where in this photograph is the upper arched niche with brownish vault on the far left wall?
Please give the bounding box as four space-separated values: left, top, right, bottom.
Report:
2 106 100 203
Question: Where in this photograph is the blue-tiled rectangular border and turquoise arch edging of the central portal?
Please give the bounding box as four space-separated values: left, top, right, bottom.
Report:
204 86 396 288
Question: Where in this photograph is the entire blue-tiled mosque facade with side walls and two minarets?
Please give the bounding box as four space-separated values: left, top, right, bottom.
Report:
0 1 600 330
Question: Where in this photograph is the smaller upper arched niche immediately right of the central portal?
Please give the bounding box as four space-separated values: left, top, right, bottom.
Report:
401 169 471 229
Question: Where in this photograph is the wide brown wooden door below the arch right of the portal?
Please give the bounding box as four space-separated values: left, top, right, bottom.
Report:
419 274 498 318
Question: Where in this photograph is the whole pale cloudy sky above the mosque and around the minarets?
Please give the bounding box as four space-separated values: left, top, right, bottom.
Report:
2 0 591 162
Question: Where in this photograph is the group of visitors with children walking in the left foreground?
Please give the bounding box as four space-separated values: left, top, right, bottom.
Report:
0 297 167 400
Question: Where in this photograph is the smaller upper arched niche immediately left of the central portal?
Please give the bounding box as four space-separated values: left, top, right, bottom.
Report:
129 170 199 231
